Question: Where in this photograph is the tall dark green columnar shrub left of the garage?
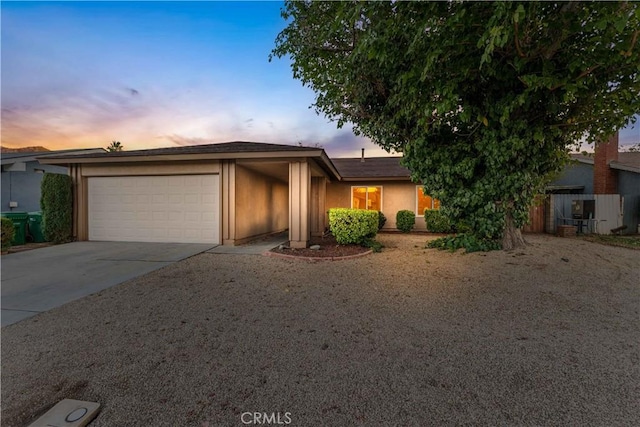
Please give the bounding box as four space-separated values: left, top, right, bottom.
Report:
40 173 73 243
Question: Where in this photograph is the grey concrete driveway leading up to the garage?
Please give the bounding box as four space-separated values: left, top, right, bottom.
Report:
1 242 214 326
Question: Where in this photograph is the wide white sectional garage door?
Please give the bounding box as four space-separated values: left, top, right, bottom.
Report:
88 175 220 244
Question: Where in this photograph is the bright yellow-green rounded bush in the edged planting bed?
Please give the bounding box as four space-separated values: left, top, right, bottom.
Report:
329 208 379 245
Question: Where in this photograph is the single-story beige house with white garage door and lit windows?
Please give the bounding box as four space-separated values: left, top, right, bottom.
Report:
40 142 438 247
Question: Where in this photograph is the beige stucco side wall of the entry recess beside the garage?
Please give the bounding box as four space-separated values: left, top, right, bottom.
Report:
235 165 289 241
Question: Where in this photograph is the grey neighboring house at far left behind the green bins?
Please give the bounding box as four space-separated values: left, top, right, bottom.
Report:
0 148 104 212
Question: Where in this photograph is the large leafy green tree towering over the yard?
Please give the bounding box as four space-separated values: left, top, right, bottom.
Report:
272 1 640 249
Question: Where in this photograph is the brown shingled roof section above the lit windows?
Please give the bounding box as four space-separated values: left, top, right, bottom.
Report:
332 157 411 181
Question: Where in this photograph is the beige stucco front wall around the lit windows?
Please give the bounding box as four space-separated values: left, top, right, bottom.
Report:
326 181 426 230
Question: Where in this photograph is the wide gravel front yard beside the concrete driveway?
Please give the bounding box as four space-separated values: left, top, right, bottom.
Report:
2 235 640 427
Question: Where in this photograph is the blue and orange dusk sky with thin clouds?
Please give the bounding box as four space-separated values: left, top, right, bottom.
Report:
0 1 640 157
